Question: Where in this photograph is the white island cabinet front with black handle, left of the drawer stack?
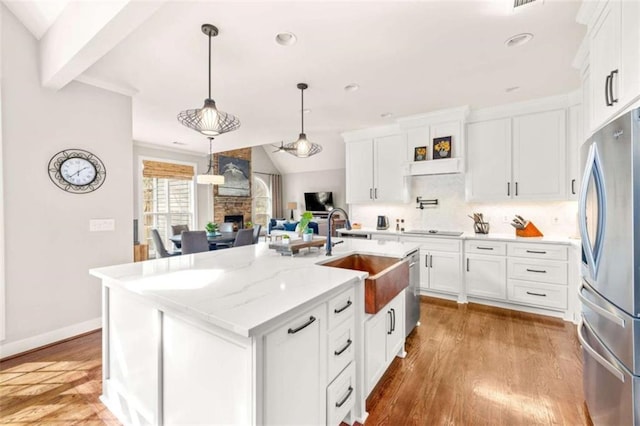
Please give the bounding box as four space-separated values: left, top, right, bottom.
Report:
264 304 327 425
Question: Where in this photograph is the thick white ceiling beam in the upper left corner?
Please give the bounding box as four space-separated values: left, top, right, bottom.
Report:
40 0 165 90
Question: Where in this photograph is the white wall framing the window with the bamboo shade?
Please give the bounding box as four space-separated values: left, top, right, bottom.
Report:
133 145 213 236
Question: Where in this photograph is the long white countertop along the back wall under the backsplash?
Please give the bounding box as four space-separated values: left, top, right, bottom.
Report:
336 228 580 245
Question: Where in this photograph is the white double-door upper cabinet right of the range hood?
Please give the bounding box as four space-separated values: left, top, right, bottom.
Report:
466 105 567 201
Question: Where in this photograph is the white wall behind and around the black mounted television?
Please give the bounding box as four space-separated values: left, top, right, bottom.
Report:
282 167 347 218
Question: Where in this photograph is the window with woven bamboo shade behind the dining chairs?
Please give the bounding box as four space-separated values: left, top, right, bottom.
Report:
142 160 195 257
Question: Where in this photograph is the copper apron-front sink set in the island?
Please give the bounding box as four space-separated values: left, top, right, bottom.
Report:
321 254 409 314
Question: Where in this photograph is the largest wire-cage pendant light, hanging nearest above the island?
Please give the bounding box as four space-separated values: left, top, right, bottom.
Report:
178 24 240 136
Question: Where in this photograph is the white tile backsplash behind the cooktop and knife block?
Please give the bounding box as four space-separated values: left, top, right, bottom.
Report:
350 174 578 238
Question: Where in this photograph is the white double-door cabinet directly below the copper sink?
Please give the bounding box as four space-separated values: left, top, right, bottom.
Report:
364 290 406 395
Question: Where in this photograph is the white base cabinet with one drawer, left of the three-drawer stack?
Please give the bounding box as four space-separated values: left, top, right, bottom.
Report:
464 240 507 300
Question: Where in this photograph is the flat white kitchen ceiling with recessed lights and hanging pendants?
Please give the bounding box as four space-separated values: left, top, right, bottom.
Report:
9 0 585 173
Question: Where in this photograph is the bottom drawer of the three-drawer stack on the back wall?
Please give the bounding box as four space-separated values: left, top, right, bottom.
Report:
507 280 567 310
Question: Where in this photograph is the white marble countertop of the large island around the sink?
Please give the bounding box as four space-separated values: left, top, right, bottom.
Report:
89 238 419 336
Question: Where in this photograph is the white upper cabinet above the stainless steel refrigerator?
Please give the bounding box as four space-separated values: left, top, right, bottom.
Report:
578 0 640 131
